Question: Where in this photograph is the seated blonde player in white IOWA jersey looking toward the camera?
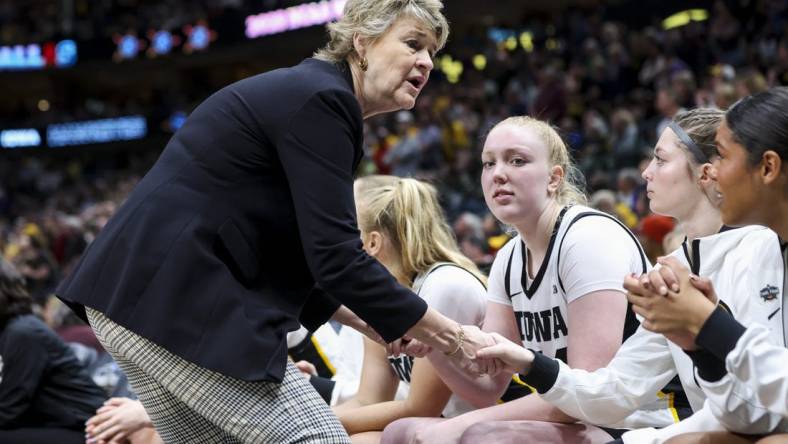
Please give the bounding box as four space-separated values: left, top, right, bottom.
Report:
384 117 673 443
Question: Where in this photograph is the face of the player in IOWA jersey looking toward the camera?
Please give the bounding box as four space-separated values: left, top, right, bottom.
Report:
482 124 551 226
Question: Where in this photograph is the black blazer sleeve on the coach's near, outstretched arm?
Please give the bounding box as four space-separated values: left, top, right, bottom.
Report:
276 91 427 341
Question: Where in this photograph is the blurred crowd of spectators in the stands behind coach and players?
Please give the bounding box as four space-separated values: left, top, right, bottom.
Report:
0 0 788 320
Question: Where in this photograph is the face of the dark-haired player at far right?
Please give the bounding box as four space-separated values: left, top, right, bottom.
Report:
714 121 763 225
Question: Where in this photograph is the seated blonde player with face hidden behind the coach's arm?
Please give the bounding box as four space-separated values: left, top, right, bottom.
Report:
334 176 485 443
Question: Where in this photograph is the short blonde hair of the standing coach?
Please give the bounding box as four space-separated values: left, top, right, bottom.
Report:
314 0 449 63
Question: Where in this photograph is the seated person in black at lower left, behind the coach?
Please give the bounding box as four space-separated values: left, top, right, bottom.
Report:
0 258 106 444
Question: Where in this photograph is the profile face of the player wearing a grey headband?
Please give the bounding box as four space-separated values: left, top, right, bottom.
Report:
643 128 705 221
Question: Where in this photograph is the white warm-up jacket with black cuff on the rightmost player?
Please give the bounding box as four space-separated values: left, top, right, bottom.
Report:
684 240 788 434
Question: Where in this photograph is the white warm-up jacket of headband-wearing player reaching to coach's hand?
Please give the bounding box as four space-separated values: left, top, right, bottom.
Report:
526 226 782 444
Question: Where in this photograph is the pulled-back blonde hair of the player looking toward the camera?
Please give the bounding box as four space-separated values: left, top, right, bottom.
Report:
493 116 588 205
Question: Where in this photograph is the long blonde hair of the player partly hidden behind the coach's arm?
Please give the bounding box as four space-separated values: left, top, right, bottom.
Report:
356 175 486 285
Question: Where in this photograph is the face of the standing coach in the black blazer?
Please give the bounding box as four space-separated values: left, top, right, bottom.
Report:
362 17 437 118
